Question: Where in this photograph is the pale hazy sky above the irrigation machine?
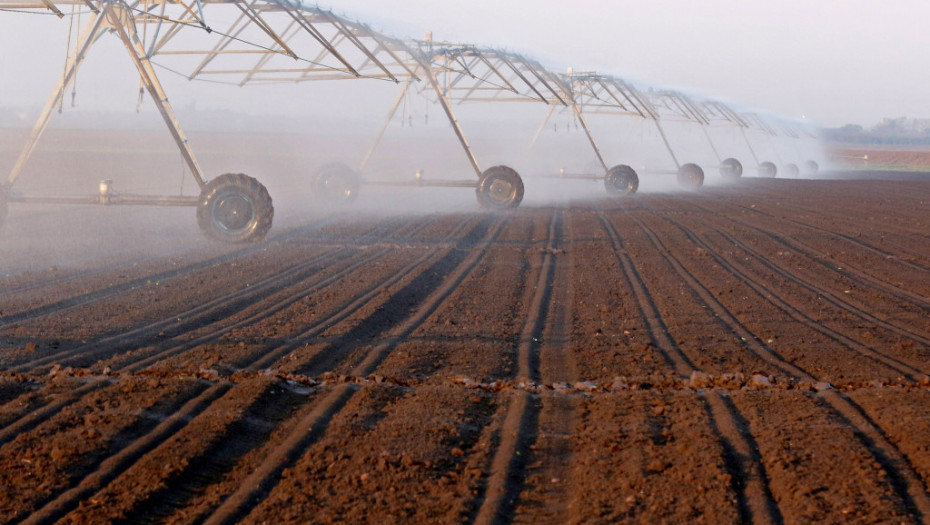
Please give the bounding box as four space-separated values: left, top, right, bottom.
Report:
0 0 930 126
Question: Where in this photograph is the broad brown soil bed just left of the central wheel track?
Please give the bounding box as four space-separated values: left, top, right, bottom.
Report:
205 212 546 522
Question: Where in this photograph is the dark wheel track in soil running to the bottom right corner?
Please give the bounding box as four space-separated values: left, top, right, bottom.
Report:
626 201 930 519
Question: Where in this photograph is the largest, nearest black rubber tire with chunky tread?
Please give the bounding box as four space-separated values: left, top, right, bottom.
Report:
197 173 274 242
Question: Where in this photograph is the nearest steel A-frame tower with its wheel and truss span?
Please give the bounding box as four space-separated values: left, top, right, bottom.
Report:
0 0 432 241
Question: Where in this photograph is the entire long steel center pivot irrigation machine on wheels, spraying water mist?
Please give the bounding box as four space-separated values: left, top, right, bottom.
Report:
0 0 820 242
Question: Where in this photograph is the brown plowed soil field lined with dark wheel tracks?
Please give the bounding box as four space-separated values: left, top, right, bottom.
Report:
0 163 930 524
